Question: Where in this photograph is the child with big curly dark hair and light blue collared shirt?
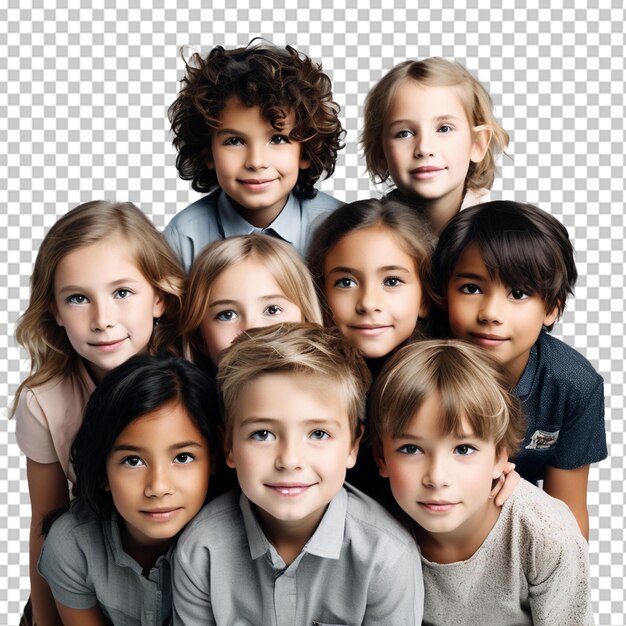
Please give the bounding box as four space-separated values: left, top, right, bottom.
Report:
165 40 344 270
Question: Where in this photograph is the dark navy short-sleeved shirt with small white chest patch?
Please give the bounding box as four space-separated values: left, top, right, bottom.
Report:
511 331 608 483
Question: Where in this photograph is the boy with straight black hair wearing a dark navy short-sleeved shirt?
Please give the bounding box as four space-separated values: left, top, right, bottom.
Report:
431 201 607 538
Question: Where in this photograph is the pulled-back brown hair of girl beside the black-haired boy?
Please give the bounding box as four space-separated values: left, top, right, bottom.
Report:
307 198 434 326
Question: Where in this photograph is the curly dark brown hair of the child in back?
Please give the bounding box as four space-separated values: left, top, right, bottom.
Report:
169 39 345 198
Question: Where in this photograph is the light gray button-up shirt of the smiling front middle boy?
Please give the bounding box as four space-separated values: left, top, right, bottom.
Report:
172 484 424 626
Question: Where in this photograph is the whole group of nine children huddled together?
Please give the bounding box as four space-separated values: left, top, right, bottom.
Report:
13 42 607 626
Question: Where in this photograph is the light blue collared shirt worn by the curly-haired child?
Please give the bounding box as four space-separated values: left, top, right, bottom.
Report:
163 188 343 272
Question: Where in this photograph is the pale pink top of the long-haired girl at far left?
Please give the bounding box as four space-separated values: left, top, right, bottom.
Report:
15 362 96 482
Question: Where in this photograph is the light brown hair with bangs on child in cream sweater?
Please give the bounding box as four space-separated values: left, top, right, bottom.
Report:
369 339 526 455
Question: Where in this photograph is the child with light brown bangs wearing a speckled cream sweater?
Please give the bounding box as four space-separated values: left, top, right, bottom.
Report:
369 339 593 626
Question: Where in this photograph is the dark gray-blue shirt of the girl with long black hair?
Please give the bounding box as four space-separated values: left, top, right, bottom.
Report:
37 507 172 626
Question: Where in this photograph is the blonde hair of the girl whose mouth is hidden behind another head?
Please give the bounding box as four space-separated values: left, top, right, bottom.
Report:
182 234 322 358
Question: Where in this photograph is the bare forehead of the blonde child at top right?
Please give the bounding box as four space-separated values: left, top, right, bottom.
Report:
387 78 469 123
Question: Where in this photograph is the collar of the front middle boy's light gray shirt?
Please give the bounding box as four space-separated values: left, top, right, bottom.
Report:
239 488 348 567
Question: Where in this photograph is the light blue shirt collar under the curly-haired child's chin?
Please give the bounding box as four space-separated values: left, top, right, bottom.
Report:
216 192 302 244
